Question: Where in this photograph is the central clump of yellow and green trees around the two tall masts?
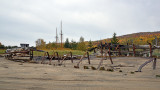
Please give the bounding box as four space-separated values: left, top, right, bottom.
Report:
35 36 93 51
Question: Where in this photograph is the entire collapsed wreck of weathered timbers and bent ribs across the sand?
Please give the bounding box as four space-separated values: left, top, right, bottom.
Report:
5 42 160 72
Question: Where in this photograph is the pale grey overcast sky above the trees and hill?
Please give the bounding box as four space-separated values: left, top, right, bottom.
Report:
0 0 160 46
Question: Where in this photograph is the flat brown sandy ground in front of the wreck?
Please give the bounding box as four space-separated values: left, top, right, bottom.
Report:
0 57 160 90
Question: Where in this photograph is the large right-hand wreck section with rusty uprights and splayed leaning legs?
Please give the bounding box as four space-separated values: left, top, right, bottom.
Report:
92 42 160 72
